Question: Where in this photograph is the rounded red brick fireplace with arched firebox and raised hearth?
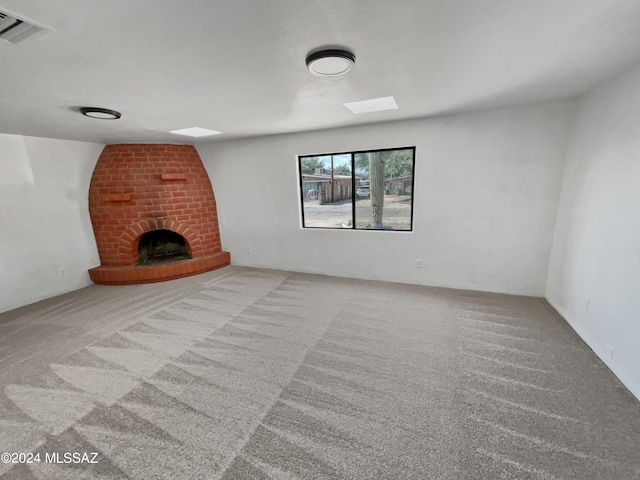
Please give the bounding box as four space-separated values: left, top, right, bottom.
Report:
89 144 230 285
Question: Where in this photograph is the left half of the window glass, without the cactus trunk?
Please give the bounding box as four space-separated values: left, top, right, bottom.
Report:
300 154 353 228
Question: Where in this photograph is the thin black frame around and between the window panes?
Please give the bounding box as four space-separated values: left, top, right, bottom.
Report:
297 145 416 232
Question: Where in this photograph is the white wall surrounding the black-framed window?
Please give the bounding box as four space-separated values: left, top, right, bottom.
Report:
198 101 575 296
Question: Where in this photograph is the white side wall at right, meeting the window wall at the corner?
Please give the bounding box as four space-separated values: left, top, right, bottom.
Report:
546 67 640 398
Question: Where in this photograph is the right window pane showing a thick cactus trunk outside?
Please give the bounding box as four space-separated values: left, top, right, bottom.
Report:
356 149 414 230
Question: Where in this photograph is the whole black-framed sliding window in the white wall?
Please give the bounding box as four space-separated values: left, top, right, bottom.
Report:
298 147 415 231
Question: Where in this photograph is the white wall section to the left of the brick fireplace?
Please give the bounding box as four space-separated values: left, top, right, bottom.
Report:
0 134 103 312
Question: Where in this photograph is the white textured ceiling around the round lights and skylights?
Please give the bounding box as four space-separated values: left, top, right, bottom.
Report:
0 0 640 143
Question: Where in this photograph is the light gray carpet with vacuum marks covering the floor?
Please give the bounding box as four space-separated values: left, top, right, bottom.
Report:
0 267 640 480
